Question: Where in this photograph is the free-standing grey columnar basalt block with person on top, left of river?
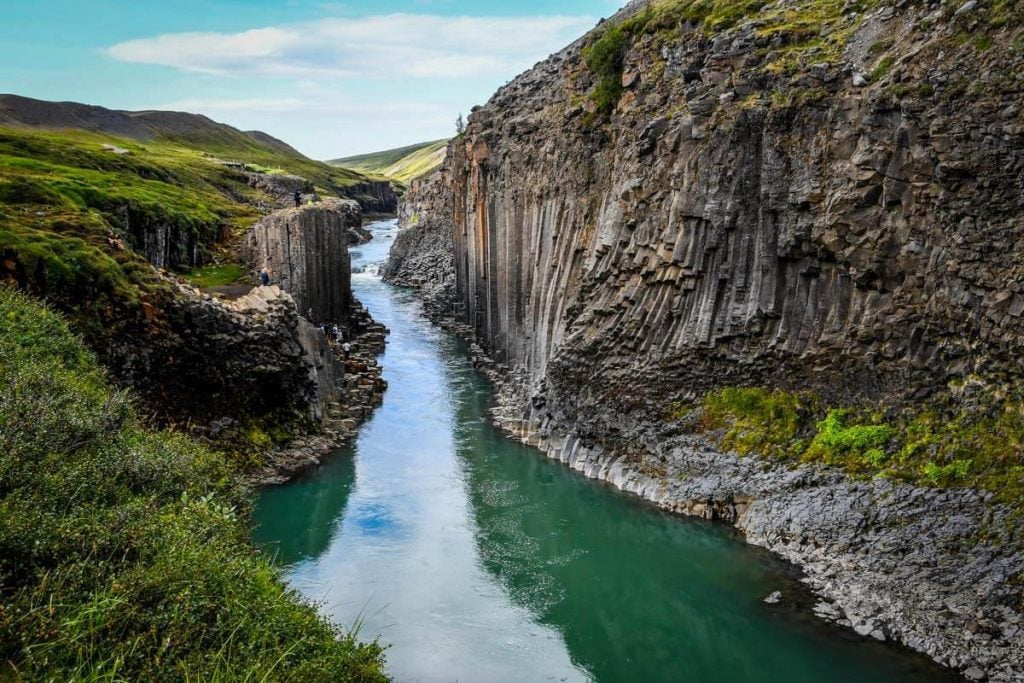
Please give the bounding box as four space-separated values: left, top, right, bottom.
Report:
243 200 361 324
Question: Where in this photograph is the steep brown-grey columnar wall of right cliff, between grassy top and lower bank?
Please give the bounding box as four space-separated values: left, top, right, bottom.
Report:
446 6 1024 415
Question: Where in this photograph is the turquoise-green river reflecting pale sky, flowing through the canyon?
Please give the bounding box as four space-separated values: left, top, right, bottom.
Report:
254 221 948 683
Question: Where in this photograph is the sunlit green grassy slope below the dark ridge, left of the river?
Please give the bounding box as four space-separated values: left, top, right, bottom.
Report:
0 128 374 313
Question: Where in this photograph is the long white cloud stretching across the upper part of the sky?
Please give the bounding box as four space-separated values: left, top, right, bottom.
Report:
106 14 594 79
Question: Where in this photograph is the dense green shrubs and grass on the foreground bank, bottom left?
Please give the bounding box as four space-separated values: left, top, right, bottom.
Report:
0 287 384 681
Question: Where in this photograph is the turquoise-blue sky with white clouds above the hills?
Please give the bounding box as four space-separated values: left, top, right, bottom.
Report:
0 0 625 160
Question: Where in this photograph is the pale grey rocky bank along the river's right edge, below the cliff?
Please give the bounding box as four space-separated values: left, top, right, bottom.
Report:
396 255 1024 681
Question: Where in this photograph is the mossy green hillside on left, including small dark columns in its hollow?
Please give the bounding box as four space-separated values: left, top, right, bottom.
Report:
0 122 385 342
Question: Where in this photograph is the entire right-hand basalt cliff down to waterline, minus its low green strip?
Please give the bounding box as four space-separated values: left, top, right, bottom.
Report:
393 1 1024 680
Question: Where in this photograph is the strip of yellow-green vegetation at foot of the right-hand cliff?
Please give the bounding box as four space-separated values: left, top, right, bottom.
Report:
672 387 1024 506
